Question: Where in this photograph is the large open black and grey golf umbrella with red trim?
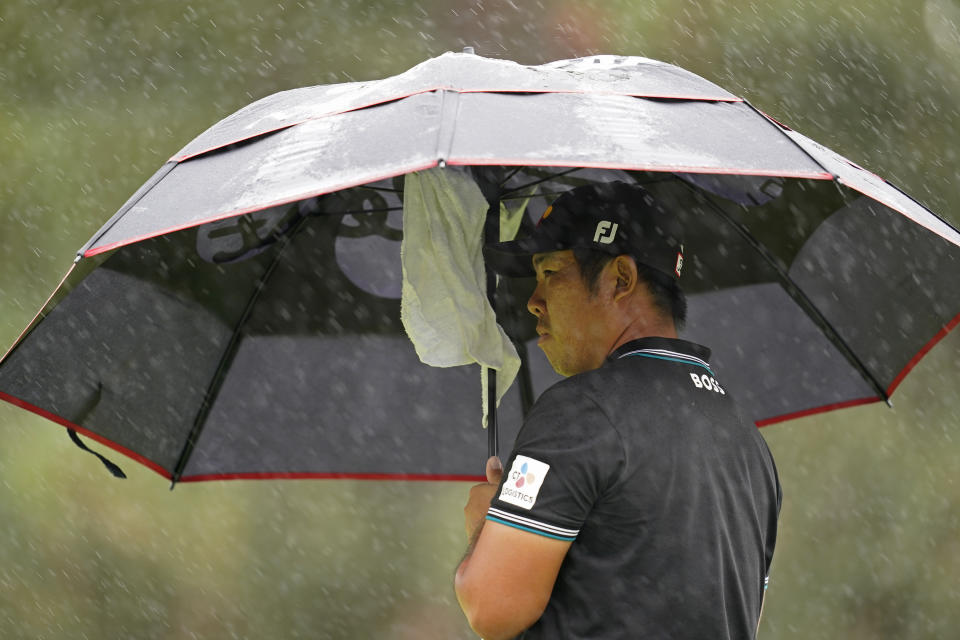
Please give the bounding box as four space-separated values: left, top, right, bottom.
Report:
0 53 960 482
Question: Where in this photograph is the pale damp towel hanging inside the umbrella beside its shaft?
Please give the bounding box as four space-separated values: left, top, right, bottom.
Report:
400 168 526 426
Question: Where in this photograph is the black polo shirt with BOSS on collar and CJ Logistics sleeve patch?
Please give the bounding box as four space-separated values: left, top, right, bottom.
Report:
487 338 781 640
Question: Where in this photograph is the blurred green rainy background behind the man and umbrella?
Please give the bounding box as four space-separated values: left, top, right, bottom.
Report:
0 0 960 640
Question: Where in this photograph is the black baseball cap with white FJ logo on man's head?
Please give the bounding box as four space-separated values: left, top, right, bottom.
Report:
484 181 683 280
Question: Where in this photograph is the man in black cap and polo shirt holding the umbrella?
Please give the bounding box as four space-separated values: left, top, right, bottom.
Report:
456 182 780 640
